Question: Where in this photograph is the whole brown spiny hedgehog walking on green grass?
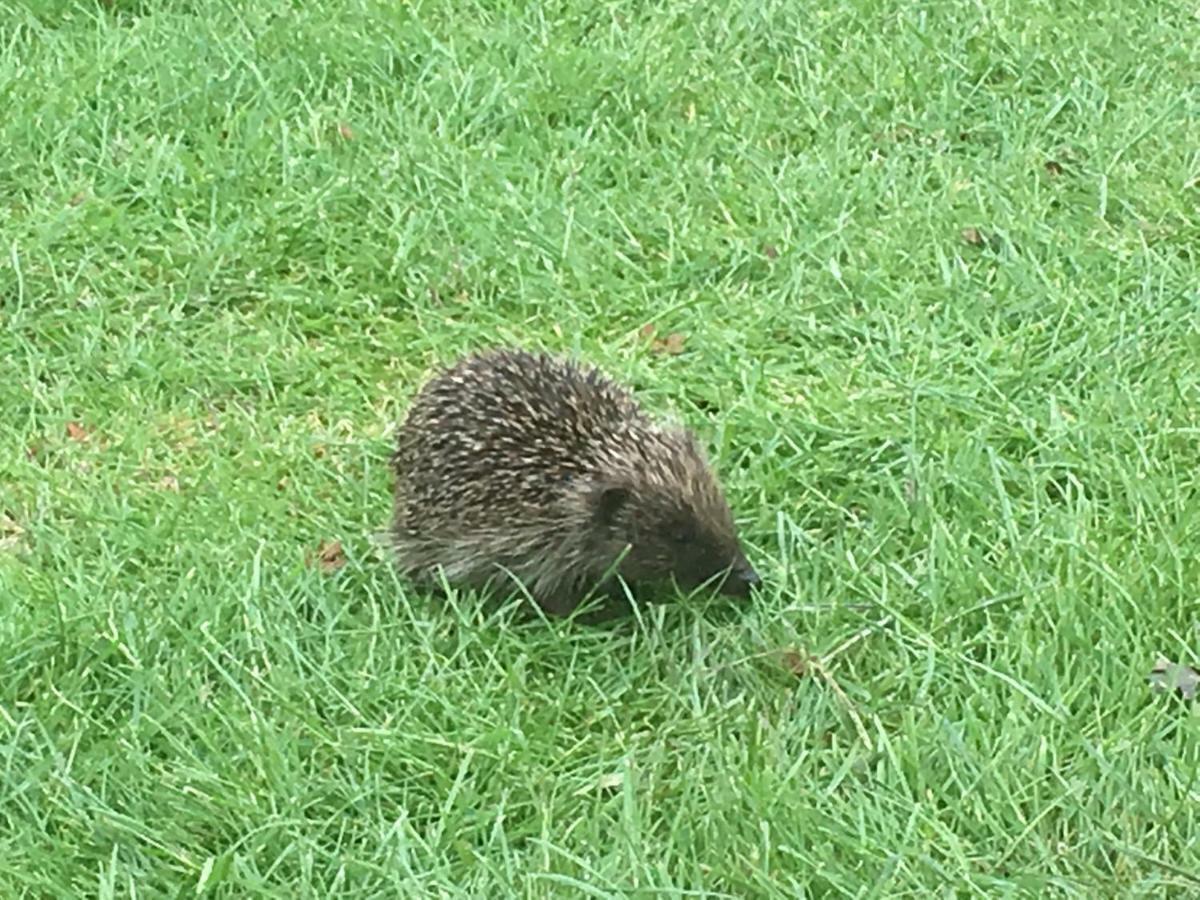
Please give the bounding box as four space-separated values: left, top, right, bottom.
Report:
391 348 760 618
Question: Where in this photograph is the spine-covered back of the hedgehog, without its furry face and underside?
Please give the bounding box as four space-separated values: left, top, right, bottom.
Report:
394 350 649 533
